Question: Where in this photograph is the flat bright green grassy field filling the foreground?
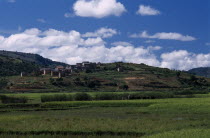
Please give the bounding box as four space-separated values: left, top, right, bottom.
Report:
0 94 210 138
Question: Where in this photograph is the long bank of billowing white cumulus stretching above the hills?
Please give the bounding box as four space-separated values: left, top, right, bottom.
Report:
0 28 210 70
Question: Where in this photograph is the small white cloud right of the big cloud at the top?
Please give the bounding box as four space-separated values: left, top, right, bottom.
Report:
136 5 161 16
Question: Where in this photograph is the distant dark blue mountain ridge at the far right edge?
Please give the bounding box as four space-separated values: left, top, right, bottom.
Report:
188 67 210 78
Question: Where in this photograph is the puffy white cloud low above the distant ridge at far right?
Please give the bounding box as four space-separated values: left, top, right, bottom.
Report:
161 50 210 70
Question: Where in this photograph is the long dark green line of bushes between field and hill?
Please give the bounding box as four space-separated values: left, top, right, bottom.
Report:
41 90 209 102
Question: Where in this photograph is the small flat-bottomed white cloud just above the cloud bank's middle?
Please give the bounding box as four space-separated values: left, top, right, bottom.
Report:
82 27 118 38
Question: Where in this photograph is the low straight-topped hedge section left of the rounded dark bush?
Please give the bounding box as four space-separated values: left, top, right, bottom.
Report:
41 94 73 102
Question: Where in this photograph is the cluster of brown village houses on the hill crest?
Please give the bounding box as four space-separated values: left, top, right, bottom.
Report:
40 61 101 78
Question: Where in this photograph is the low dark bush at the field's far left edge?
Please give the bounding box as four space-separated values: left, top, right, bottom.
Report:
0 95 28 104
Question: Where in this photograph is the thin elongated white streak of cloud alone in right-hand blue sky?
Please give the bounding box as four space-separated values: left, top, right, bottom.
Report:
130 31 196 41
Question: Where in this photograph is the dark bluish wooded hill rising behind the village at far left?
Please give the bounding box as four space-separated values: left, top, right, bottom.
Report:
0 51 66 76
